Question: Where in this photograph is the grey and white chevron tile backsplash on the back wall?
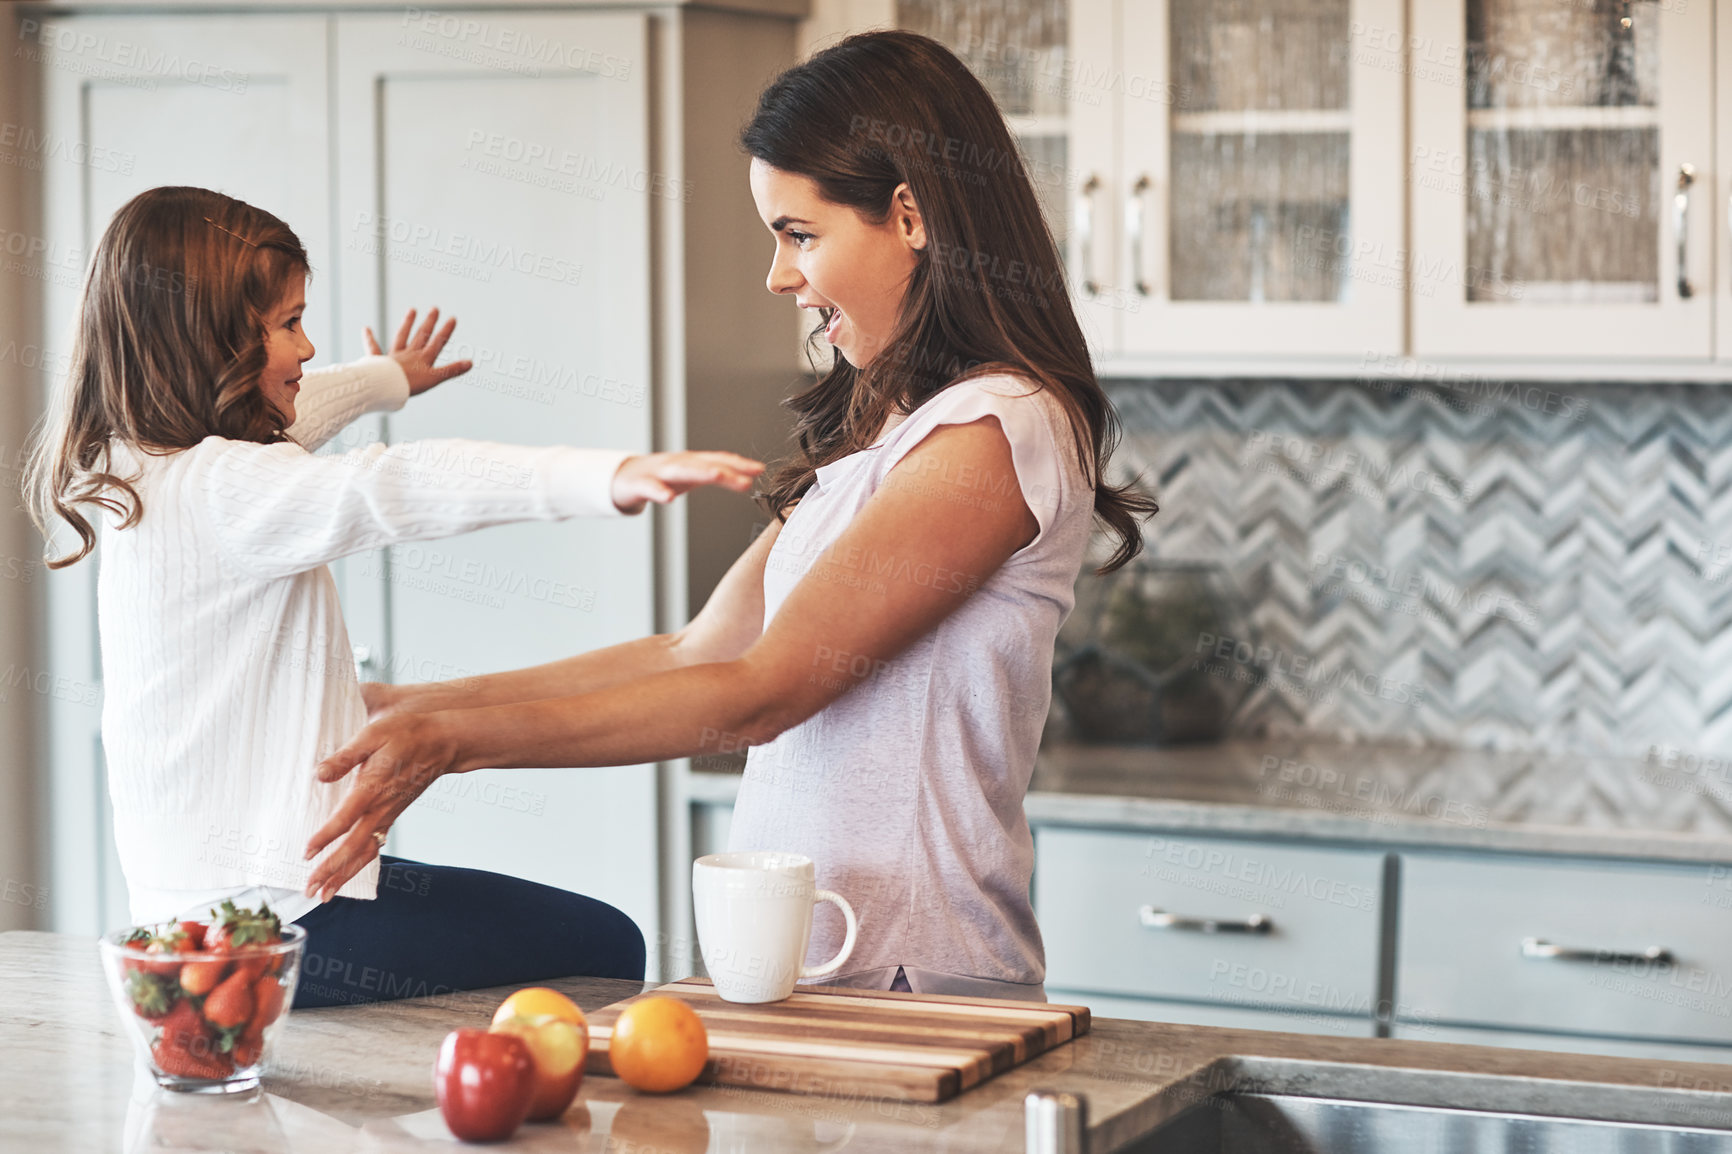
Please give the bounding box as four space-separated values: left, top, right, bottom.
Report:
1108 378 1732 755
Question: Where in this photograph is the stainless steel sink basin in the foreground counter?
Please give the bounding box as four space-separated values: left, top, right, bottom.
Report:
1124 1092 1732 1154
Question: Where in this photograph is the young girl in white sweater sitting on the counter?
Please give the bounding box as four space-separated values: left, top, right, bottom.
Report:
31 187 760 1005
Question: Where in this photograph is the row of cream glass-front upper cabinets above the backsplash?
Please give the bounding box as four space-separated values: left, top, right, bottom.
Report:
814 0 1732 370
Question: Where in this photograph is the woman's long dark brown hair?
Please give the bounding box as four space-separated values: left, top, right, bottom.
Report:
740 31 1157 572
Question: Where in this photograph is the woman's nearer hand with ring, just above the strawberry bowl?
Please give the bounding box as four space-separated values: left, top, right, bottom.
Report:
307 714 457 901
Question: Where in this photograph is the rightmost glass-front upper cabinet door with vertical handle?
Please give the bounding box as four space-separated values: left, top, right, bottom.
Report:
1408 0 1718 359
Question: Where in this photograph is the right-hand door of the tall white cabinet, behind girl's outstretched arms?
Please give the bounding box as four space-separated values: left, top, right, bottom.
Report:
334 9 665 943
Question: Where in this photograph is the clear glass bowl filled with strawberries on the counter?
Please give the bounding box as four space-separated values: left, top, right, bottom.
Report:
99 925 307 1093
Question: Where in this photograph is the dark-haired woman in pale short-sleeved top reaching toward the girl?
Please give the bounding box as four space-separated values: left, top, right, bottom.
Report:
310 31 1154 998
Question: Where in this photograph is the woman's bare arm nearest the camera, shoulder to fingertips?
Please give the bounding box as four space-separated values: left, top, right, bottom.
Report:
307 418 1039 896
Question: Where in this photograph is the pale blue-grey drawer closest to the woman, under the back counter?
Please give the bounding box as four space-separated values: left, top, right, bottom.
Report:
1034 828 1384 1017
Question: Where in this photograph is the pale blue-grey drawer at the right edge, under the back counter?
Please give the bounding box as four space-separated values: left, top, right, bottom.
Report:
1396 854 1732 1041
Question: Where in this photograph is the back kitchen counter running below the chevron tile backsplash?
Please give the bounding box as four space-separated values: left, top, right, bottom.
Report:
688 738 1732 861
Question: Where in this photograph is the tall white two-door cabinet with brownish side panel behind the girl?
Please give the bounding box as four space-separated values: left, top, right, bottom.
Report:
31 0 798 974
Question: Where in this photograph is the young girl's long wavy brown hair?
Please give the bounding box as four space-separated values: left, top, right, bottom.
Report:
24 187 308 568
